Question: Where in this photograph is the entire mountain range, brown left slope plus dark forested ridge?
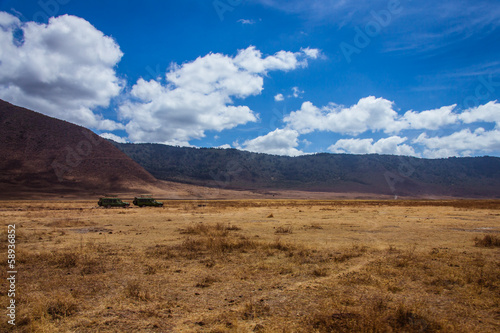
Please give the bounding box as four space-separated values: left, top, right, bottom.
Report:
0 100 500 198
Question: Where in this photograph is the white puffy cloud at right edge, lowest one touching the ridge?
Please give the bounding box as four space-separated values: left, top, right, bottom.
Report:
413 128 500 158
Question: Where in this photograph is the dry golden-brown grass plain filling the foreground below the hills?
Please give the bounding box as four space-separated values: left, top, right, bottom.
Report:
0 200 500 333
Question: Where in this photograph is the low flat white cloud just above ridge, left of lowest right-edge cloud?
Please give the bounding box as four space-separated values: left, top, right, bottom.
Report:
328 136 417 156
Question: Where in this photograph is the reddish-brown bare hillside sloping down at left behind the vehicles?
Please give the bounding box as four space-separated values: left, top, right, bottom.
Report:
0 100 157 197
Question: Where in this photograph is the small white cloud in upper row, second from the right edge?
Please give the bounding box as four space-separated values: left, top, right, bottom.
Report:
403 104 458 130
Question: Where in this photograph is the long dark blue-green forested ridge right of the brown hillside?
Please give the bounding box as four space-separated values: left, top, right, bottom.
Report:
113 143 500 198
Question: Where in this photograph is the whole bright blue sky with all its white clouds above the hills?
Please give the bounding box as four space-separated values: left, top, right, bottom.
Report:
0 0 500 158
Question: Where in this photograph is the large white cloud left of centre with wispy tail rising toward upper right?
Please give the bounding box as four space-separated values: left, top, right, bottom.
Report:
119 46 318 145
